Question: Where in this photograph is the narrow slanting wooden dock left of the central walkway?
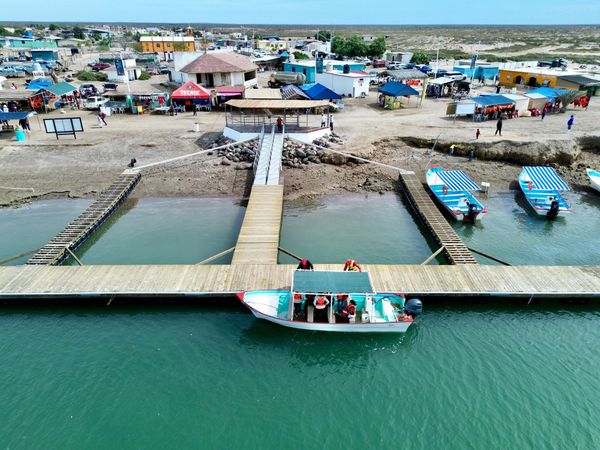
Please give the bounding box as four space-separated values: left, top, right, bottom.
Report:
27 170 141 265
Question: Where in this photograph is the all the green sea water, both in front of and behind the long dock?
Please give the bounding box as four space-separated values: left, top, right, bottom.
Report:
0 193 600 449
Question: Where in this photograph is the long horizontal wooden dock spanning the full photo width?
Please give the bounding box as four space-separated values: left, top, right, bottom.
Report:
0 264 600 300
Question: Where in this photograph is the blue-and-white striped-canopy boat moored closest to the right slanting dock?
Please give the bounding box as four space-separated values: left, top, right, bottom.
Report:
426 167 487 223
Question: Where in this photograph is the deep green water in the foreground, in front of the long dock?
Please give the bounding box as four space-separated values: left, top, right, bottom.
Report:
0 305 600 449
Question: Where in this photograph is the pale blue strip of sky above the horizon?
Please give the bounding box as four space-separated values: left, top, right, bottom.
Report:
0 0 600 25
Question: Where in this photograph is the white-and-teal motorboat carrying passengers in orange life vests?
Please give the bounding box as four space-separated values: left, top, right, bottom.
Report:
238 270 423 333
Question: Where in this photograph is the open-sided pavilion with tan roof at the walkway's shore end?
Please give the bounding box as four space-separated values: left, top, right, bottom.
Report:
225 99 329 133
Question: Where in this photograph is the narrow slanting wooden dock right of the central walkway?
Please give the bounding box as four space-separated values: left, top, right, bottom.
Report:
399 174 477 264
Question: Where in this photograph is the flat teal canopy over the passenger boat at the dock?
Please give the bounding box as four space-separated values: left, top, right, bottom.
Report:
292 270 374 294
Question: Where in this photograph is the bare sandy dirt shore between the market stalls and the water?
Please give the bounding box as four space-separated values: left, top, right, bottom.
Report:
0 76 600 206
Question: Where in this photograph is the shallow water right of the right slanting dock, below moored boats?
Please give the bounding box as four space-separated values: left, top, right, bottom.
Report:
454 191 600 265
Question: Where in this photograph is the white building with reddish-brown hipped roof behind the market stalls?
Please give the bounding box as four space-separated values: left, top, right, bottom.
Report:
174 52 258 88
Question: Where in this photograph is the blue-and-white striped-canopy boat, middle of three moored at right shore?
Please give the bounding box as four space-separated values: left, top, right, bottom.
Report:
519 166 571 219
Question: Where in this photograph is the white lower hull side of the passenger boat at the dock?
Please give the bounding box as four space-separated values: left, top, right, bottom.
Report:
246 304 412 333
